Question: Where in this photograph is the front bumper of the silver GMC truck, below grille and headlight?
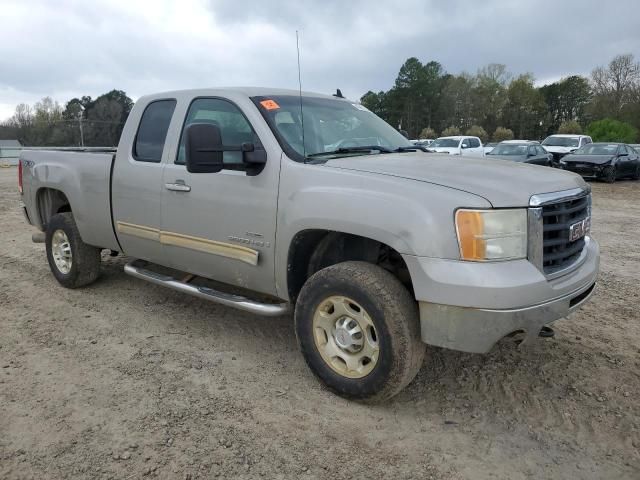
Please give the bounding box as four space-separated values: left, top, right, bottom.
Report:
405 238 600 353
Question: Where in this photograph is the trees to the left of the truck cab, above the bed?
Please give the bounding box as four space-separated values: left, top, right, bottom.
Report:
0 90 133 147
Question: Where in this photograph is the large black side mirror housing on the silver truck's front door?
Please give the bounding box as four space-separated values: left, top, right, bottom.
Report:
185 123 223 173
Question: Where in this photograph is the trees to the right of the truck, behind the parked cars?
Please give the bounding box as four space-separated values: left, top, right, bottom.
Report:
360 54 640 143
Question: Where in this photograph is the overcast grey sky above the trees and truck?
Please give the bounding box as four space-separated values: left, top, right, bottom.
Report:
0 0 640 120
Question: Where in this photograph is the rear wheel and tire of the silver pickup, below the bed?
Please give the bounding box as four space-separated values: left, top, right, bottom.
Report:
45 212 100 288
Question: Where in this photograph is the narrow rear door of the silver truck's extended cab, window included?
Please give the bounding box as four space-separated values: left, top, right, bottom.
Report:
111 98 176 264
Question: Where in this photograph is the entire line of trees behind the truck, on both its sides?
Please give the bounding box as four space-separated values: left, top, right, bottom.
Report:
0 54 640 147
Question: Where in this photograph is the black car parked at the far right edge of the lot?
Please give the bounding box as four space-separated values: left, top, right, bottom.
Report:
560 143 640 183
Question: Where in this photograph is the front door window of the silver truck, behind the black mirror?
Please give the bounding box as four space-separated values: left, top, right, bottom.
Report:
175 98 262 167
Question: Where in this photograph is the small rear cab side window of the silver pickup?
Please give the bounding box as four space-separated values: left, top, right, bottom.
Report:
133 100 176 163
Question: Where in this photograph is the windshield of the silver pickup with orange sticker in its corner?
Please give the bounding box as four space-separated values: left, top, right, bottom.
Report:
253 95 412 161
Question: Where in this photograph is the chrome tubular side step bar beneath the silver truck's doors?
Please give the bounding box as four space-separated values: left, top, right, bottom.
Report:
124 260 289 317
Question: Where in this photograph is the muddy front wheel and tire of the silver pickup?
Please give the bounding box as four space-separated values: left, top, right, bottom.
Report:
295 262 425 402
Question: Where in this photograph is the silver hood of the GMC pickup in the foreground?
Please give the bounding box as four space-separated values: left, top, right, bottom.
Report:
325 153 587 207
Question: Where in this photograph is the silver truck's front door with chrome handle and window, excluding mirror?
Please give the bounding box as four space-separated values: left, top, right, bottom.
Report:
161 97 281 294
